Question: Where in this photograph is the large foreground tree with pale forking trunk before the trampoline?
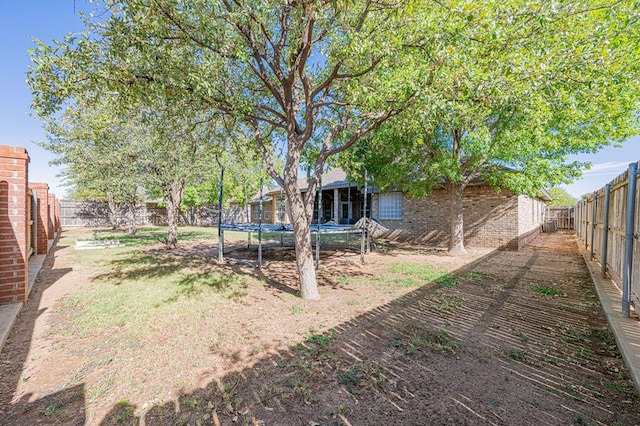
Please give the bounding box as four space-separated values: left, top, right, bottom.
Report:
30 0 410 299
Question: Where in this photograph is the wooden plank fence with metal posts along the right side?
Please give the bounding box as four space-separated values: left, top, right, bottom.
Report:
576 161 640 316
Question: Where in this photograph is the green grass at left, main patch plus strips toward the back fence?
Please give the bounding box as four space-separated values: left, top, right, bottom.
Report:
53 227 254 341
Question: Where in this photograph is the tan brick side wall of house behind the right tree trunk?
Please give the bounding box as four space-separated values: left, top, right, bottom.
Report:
371 186 541 250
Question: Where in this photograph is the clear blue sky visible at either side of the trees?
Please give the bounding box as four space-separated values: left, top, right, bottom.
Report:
0 0 640 197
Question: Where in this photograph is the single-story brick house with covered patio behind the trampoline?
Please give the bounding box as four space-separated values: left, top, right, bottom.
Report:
245 168 551 250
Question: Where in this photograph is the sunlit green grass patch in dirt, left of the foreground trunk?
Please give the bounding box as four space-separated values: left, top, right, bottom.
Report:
55 257 251 339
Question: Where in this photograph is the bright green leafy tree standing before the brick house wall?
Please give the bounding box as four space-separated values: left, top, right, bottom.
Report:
347 0 639 252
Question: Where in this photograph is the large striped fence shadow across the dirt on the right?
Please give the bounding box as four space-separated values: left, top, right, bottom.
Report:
91 235 640 425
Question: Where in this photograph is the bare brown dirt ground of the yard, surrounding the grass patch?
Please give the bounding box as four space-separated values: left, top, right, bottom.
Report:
0 233 640 425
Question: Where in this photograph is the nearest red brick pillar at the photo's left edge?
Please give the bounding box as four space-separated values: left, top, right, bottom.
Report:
0 146 29 303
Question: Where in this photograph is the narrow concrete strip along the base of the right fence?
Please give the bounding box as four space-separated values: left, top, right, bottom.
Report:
578 243 640 392
